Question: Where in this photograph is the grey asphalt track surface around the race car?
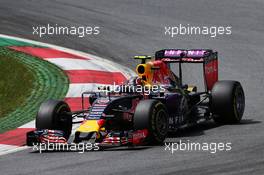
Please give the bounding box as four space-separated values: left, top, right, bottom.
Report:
0 0 264 175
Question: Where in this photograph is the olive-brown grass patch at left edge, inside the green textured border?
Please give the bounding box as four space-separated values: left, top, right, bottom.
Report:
0 53 35 117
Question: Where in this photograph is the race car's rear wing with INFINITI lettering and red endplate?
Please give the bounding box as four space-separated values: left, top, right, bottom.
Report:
155 49 218 91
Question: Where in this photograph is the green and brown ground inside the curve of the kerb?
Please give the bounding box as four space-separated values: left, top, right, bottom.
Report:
0 47 69 133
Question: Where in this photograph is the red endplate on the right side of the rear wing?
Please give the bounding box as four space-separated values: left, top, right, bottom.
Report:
204 59 218 90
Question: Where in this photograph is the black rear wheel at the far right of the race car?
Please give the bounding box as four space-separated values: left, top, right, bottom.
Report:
211 81 245 124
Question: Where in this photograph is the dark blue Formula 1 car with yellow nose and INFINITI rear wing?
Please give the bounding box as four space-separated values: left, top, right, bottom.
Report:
27 49 245 146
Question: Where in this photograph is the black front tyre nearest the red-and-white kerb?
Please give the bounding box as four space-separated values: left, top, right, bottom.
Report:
36 100 72 139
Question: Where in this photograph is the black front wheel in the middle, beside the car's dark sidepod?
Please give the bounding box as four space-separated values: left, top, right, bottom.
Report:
134 100 169 144
